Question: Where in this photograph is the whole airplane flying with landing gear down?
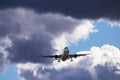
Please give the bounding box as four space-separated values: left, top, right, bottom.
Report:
43 47 88 62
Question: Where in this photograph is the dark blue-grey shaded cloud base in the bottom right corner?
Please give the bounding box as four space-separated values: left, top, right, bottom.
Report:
95 64 120 80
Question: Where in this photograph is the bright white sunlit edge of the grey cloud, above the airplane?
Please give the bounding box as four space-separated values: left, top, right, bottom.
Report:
53 20 98 51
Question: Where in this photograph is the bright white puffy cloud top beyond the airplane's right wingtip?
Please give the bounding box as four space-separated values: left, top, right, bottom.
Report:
91 45 120 66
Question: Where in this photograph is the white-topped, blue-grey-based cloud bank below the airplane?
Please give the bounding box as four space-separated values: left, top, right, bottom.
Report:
17 45 120 80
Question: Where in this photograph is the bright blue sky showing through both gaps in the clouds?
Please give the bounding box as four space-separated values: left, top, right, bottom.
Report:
0 20 120 80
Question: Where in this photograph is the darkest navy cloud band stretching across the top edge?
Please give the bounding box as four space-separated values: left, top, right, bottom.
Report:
0 0 120 19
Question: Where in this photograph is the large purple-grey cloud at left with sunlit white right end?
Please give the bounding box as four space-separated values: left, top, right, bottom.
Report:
0 8 95 67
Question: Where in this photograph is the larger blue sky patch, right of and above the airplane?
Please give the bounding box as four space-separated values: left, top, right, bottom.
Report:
70 20 120 53
